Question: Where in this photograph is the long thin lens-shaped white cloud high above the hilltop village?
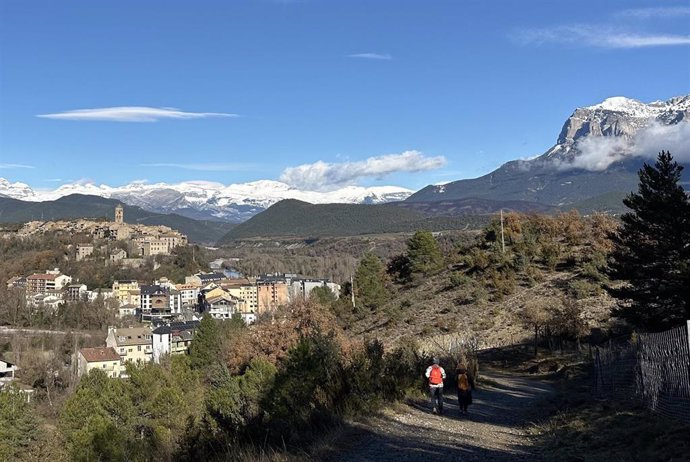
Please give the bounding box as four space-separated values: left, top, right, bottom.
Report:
36 106 239 122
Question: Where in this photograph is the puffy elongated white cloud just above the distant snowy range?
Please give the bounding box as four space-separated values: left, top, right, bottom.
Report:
280 151 446 191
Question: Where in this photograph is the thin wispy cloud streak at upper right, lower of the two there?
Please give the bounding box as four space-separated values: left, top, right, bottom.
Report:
513 24 690 48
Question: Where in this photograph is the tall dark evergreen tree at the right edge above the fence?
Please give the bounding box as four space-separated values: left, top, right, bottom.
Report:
608 151 690 331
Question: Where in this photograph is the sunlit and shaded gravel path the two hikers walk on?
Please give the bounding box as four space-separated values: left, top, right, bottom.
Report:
325 372 554 462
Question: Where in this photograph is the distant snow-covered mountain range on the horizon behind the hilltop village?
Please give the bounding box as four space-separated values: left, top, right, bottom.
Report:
0 178 413 222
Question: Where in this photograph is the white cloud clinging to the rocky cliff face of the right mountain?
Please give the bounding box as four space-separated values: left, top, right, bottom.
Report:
556 122 690 171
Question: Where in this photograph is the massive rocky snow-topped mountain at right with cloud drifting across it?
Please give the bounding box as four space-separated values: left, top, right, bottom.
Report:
407 95 690 206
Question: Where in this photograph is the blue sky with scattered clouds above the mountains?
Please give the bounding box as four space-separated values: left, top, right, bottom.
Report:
0 0 690 189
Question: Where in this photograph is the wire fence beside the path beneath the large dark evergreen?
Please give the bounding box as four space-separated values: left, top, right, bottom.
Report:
594 321 690 422
